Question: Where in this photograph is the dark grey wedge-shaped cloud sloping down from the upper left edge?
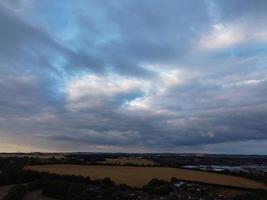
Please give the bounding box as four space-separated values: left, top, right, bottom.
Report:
0 7 103 75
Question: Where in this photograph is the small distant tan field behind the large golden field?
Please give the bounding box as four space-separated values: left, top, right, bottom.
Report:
100 157 156 166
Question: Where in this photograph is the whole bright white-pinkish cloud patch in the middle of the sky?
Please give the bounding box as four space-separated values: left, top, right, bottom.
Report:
66 69 196 112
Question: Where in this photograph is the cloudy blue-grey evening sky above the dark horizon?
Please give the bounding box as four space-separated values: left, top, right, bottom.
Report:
0 0 267 154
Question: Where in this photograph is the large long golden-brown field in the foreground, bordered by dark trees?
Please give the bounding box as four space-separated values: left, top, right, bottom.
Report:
25 165 267 190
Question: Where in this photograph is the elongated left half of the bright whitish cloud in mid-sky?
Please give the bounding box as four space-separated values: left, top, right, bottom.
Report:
66 74 149 108
